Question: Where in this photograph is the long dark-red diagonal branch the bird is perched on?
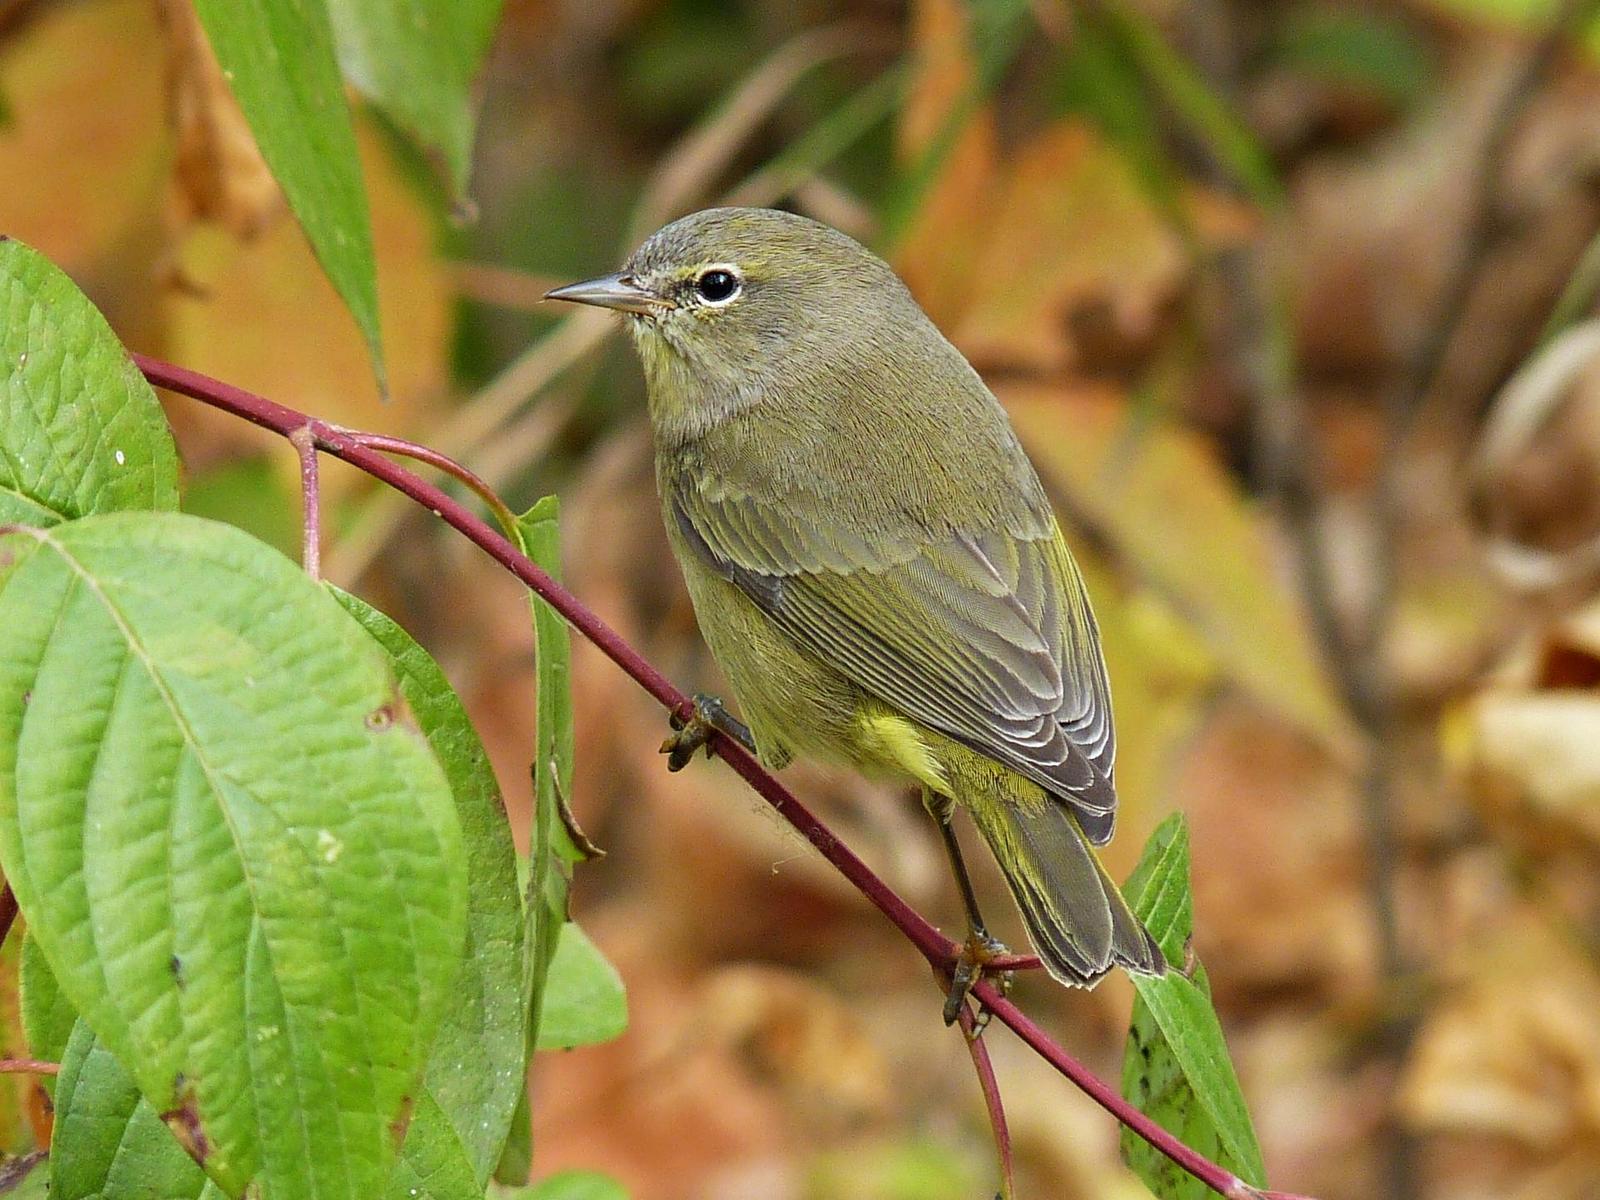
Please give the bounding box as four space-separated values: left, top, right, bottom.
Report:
134 354 1304 1200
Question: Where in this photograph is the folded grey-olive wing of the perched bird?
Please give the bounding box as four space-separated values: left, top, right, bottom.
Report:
670 486 1115 843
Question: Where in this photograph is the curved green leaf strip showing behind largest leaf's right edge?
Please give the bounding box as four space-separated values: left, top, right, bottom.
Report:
330 586 525 1192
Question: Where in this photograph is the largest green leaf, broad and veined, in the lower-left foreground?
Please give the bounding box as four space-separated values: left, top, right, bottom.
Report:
0 514 466 1200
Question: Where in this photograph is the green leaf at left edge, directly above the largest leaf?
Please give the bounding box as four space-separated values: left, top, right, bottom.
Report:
0 238 178 526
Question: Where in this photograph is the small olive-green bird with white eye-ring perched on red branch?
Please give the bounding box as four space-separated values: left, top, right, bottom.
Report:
550 208 1165 1019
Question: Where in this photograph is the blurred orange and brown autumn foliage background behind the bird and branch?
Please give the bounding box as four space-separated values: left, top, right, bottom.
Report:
9 0 1600 1200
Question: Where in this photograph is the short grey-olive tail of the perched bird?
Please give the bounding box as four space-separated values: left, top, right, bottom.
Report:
968 800 1166 987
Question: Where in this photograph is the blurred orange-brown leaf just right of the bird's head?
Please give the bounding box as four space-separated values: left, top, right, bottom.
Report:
954 120 1187 368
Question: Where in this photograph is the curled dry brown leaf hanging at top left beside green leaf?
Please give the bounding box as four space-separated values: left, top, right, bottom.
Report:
155 0 283 238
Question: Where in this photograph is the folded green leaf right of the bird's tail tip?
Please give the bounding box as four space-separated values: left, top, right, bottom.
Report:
1122 813 1266 1200
